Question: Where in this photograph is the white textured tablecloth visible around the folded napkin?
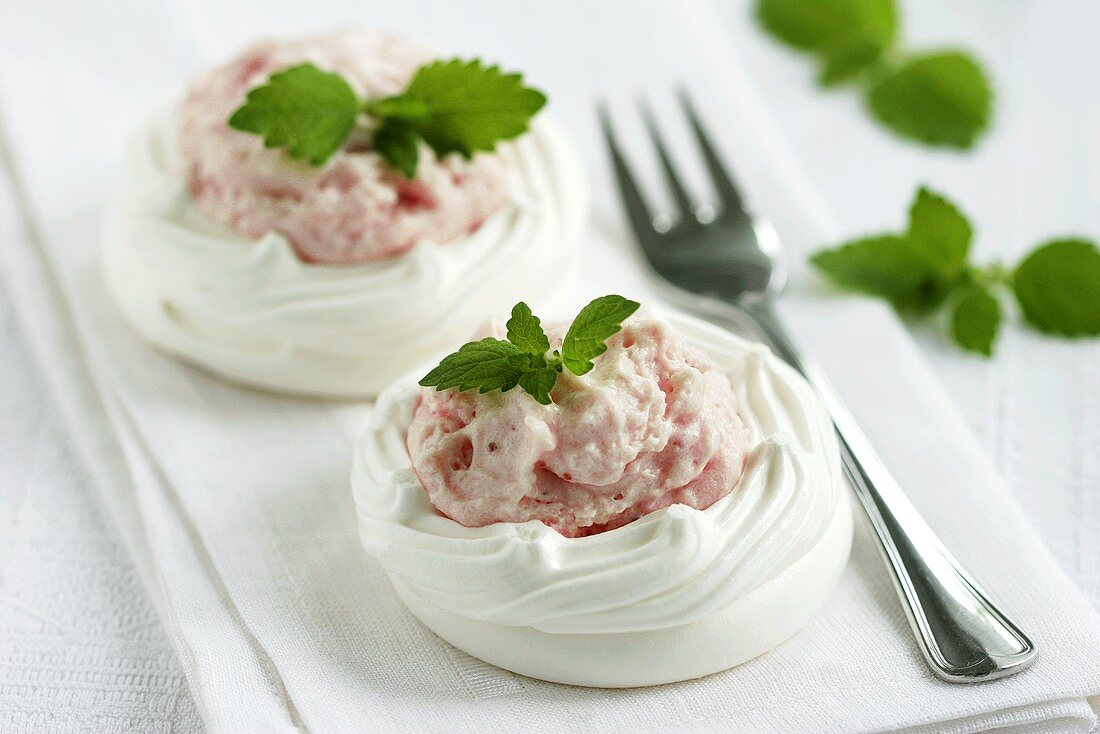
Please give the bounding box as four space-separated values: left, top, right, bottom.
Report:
0 0 1100 731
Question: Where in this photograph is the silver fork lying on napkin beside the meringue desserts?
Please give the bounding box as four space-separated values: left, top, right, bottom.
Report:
597 91 1035 682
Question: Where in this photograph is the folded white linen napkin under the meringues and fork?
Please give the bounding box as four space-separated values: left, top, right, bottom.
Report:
0 0 1100 732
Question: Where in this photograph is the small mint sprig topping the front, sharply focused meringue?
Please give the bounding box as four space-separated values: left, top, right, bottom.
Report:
419 295 639 405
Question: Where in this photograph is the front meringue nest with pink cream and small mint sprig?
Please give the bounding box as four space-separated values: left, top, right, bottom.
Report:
352 297 851 687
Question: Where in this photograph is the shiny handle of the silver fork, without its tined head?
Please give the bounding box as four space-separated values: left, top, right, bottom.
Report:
745 299 1035 682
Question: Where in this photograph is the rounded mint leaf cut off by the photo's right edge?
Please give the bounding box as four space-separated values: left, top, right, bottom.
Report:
1013 239 1100 337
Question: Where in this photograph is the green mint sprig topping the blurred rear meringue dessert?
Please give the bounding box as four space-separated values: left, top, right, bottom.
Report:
229 58 547 178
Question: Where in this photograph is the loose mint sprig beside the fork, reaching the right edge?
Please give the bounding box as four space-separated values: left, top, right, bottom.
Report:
810 187 1100 357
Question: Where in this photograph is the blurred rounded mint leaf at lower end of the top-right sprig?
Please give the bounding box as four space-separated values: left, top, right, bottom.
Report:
866 50 993 149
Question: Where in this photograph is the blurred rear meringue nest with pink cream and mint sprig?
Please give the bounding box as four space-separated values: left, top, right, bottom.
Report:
102 29 587 397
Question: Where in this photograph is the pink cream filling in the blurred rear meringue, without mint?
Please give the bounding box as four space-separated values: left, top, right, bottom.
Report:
178 29 508 264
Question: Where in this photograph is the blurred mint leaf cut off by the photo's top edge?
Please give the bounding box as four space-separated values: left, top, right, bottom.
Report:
756 0 898 86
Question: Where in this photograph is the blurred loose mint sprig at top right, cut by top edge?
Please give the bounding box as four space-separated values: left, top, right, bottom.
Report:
756 0 993 150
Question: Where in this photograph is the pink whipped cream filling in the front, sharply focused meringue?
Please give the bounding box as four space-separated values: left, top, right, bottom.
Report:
408 318 748 537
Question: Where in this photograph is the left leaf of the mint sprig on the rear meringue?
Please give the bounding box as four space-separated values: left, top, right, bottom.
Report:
229 64 360 166
